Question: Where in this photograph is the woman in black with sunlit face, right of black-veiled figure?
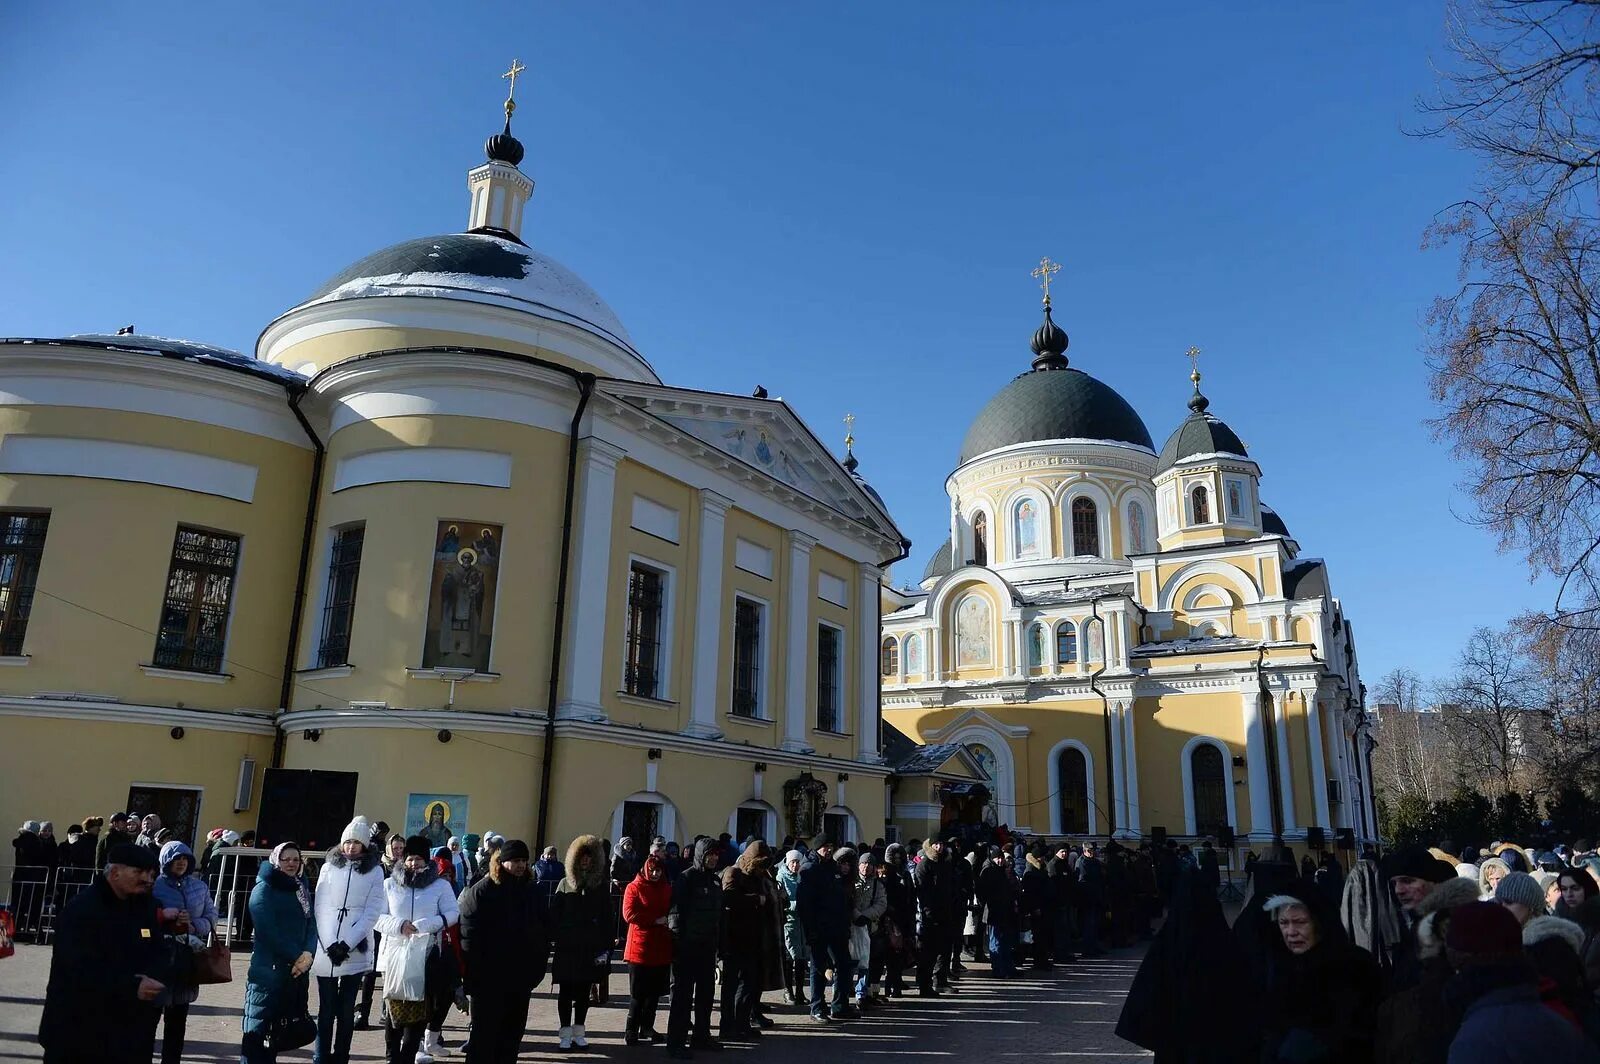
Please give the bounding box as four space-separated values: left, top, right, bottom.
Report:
1254 883 1379 1064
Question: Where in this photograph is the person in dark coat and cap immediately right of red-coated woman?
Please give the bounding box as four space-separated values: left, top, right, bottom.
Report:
667 838 722 1059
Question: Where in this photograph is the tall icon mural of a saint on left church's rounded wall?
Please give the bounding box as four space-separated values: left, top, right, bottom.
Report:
422 520 501 672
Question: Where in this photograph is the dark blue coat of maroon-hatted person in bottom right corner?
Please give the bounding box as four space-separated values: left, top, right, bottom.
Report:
1448 958 1600 1064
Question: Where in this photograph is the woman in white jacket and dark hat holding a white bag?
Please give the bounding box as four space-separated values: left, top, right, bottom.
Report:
378 835 461 1064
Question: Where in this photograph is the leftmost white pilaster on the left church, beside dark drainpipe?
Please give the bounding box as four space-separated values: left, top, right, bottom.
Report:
555 437 627 720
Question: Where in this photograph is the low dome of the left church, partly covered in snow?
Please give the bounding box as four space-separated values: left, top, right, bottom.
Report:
301 232 638 355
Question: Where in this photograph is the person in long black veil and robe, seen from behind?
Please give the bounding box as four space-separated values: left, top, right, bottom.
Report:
1117 867 1258 1064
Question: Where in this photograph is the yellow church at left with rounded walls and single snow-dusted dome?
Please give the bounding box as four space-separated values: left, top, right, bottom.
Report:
0 70 909 845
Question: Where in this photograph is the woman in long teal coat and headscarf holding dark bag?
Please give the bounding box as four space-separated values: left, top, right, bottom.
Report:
238 842 317 1064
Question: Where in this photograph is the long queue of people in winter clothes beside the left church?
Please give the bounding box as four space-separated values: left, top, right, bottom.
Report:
21 816 1122 1064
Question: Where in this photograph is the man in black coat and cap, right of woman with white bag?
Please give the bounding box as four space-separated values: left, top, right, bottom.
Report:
461 838 550 1064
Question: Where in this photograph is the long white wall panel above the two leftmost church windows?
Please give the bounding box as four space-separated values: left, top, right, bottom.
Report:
0 434 258 502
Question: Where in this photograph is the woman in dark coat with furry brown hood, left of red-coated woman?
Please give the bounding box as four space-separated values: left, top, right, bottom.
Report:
550 835 604 1050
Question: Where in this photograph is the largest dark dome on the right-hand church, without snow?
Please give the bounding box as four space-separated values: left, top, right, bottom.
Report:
962 370 1155 462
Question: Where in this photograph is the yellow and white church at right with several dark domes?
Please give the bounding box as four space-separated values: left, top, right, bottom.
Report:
878 284 1376 851
